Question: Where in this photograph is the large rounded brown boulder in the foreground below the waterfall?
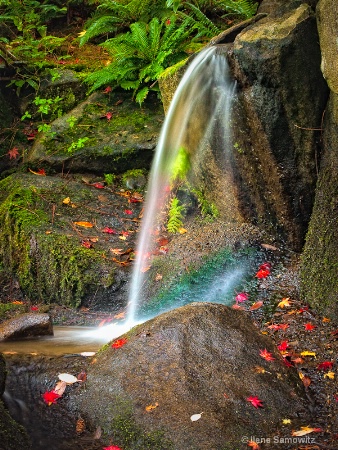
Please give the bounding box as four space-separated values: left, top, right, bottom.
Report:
70 303 308 450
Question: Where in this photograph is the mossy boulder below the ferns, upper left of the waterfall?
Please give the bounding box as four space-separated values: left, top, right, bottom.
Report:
28 91 163 174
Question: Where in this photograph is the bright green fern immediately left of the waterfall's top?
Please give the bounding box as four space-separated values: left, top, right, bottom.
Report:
85 17 195 104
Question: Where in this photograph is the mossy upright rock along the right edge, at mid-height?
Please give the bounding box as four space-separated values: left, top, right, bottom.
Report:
301 92 338 319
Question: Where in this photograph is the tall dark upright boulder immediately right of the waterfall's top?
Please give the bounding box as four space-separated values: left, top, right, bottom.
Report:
232 4 328 250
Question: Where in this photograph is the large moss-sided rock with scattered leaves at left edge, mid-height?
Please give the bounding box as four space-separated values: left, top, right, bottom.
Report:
0 174 141 309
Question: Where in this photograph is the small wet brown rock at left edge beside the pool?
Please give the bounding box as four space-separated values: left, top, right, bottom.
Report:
0 313 53 340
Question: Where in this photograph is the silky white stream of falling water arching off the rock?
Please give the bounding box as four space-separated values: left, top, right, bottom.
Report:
127 46 235 324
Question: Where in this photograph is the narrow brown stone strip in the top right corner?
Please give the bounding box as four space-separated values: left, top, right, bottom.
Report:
316 0 338 94
